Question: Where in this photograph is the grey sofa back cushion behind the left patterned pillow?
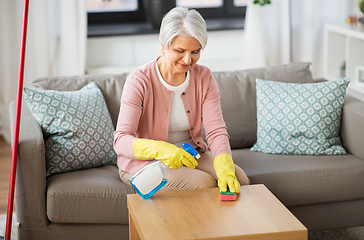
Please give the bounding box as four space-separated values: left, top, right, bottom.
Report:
31 73 128 128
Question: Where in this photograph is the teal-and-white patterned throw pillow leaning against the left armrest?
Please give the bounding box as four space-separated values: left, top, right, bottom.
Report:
24 82 117 177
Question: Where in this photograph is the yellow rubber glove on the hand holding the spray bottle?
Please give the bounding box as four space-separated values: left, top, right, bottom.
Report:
133 138 197 169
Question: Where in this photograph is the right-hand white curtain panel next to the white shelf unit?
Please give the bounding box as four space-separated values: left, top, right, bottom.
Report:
291 0 359 78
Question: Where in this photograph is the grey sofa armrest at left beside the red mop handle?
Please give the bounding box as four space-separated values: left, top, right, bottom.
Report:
9 101 48 234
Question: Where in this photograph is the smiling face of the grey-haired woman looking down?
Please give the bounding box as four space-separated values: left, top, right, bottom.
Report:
161 36 201 74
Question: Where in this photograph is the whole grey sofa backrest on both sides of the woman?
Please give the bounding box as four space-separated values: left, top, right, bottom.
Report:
32 63 313 149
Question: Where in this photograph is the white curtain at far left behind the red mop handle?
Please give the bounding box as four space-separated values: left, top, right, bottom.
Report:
0 0 87 142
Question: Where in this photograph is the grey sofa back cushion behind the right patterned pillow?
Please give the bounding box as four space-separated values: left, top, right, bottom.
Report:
210 63 313 149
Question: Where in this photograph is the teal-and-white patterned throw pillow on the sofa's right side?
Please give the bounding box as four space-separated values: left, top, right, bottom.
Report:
250 78 350 155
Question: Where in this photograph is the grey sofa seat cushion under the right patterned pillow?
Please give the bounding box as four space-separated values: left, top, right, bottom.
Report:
232 149 364 207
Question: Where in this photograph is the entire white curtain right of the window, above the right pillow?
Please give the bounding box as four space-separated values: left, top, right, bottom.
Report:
243 0 358 78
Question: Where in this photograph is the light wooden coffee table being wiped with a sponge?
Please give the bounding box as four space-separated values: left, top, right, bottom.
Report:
127 184 307 240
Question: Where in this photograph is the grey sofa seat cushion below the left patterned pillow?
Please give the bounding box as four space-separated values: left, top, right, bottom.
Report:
47 166 135 224
